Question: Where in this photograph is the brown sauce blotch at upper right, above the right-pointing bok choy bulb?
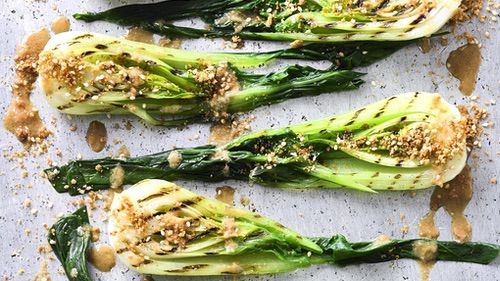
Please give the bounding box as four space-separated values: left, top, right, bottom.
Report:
446 44 481 96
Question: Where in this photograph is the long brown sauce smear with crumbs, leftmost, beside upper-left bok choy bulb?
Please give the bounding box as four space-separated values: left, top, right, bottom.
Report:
3 28 50 147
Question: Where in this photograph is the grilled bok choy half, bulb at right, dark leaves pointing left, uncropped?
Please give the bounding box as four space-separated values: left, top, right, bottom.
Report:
46 92 478 195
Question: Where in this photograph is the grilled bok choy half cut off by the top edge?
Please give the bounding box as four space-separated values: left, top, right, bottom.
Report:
74 0 460 42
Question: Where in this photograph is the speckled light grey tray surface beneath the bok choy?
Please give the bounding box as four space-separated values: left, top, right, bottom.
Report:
0 0 500 281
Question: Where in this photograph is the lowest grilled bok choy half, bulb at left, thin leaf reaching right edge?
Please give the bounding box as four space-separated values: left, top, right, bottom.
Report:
109 180 500 275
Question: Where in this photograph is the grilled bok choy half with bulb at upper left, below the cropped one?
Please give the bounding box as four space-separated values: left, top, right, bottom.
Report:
39 32 364 126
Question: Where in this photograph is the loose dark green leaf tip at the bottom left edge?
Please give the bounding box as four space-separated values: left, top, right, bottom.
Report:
48 207 92 281
